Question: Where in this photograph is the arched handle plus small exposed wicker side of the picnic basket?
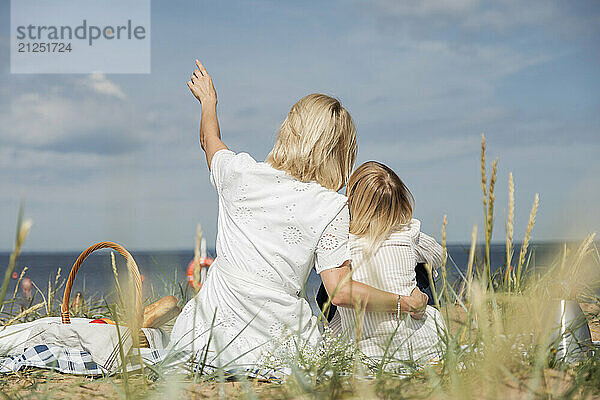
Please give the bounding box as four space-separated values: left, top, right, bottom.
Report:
60 242 149 347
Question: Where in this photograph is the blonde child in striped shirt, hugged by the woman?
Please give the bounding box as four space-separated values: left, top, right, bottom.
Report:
338 161 445 366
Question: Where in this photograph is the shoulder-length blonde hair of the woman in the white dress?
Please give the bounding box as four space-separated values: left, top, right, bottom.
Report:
266 94 356 191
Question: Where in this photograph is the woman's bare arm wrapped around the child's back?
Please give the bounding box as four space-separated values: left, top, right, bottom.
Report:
321 262 427 319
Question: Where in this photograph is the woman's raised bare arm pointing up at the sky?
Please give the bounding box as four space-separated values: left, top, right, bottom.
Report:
187 60 227 169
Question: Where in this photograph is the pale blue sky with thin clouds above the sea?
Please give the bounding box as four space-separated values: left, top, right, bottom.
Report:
0 0 600 250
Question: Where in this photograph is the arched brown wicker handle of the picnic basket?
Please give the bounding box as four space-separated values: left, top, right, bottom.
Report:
60 242 143 326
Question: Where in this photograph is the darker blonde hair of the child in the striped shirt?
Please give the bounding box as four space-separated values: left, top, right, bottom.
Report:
347 161 415 251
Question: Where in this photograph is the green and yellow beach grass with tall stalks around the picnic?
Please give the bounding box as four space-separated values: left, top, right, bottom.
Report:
0 142 600 399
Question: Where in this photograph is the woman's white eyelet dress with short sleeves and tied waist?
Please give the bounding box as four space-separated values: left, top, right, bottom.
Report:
171 150 350 370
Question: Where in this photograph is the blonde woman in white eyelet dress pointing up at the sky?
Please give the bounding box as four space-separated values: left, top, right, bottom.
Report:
171 60 427 370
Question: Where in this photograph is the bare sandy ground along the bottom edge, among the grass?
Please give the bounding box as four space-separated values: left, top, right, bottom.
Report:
0 303 600 400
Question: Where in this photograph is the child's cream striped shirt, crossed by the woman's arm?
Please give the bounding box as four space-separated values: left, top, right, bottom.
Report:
338 219 445 361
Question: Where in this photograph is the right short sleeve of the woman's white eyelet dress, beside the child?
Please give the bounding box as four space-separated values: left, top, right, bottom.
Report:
315 205 350 274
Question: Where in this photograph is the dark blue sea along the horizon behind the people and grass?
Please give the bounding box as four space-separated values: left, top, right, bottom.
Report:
0 243 572 318
